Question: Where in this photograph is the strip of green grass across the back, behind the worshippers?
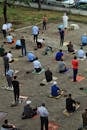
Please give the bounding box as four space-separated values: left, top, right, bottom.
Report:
0 5 87 28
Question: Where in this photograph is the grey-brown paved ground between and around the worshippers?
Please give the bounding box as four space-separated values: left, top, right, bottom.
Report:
0 20 87 130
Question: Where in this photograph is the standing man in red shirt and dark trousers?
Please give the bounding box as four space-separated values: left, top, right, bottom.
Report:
71 56 79 82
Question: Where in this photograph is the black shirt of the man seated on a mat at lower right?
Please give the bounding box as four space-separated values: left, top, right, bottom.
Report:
66 98 76 112
